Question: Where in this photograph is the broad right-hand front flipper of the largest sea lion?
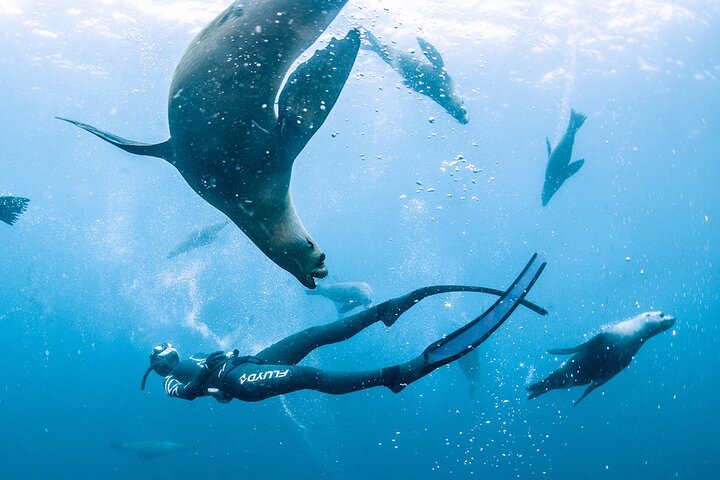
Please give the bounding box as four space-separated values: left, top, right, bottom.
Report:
278 29 360 152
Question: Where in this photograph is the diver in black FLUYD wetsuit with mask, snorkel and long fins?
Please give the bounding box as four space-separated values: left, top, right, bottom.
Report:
140 255 547 403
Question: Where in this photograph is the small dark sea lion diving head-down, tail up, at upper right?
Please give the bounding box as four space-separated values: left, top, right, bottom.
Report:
542 110 587 207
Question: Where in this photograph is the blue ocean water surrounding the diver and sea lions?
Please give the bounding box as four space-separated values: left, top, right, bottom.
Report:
0 0 720 480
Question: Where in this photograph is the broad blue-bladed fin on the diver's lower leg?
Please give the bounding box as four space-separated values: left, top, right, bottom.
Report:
423 253 547 370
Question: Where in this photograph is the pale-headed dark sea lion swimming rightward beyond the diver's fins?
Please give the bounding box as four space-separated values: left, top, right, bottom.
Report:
527 312 675 406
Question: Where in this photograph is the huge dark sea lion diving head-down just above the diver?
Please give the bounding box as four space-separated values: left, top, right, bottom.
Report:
61 0 360 288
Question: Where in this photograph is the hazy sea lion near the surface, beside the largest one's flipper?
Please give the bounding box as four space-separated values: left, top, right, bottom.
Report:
362 30 468 125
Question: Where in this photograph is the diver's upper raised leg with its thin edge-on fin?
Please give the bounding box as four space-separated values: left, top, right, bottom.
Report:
255 285 547 365
